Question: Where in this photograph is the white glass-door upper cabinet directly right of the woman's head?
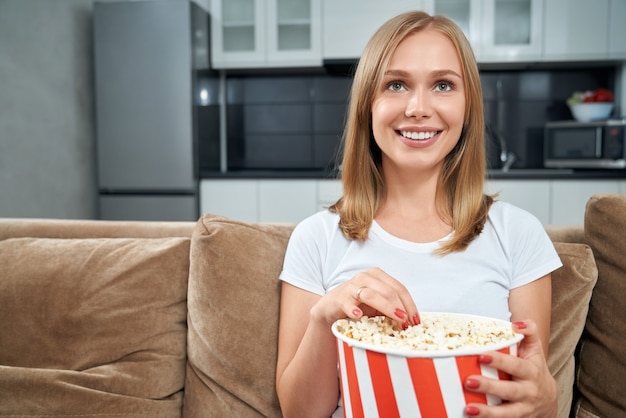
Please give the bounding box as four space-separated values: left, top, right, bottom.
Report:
424 0 544 63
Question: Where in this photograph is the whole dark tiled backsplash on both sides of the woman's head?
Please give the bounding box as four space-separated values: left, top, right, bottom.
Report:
214 66 616 171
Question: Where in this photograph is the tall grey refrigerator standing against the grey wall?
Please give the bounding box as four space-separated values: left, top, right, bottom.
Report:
94 0 219 221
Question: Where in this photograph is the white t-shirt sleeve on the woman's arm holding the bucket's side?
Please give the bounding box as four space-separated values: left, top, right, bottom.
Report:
507 206 563 289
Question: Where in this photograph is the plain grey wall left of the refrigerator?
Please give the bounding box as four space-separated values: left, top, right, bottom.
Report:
0 0 208 219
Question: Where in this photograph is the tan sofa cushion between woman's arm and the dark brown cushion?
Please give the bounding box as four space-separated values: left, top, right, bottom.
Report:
548 242 598 418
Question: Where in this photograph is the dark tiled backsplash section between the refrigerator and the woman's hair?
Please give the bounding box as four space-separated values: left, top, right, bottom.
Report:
226 74 351 171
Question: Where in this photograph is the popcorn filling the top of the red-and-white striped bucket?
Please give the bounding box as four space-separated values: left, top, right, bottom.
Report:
336 312 516 351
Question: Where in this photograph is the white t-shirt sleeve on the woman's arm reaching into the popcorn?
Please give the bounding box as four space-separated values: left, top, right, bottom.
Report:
280 216 327 295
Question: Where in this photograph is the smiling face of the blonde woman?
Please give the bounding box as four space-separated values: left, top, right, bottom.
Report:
372 29 465 172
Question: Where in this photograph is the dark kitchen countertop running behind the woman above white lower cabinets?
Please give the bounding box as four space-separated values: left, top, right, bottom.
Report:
200 168 626 180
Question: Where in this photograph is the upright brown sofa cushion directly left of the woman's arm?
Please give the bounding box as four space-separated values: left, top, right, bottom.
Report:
184 215 292 418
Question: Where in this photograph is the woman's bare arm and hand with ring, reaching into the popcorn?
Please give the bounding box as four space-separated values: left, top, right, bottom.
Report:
276 268 419 418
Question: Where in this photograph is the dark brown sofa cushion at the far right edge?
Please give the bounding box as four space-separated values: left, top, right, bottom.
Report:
576 194 626 418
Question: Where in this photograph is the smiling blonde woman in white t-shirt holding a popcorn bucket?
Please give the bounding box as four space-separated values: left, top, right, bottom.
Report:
276 12 561 418
